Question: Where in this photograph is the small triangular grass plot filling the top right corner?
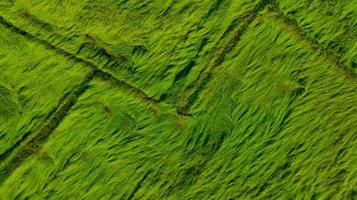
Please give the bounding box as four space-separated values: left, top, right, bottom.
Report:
278 0 357 70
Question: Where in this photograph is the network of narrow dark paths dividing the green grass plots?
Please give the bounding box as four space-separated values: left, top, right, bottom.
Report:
0 0 355 189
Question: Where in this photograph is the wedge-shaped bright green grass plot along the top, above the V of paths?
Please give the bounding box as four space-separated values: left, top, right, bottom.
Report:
2 0 261 99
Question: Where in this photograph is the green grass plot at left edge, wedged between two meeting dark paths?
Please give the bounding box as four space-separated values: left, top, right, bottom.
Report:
0 25 89 155
